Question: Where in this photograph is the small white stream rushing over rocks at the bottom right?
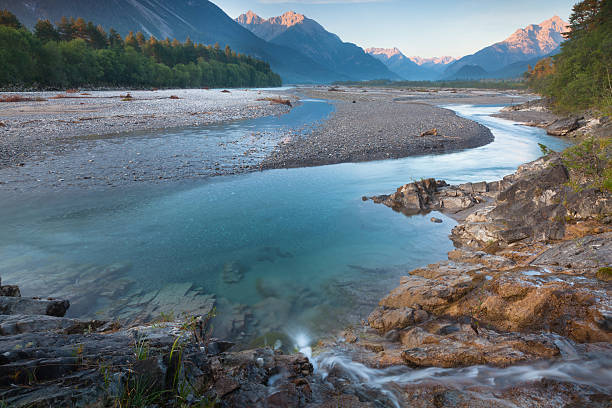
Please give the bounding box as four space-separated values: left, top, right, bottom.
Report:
302 349 612 408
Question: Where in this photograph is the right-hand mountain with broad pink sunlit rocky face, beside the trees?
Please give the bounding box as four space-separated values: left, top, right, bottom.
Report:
445 16 568 76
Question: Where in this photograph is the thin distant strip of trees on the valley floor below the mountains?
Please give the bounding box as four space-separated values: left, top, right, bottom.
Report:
334 79 526 89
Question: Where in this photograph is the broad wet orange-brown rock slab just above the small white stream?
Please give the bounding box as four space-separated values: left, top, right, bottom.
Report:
369 245 612 342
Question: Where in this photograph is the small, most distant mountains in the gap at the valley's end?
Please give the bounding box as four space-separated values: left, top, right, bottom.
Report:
366 48 454 81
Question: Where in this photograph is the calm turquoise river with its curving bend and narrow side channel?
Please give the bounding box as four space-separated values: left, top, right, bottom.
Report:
0 100 567 337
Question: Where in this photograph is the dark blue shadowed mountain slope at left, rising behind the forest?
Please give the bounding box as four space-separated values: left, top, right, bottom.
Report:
0 0 337 82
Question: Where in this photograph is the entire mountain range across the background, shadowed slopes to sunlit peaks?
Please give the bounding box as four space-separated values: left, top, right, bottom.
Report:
0 0 568 83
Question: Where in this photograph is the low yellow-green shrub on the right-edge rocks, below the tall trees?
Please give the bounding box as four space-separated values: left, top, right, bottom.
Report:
563 137 612 192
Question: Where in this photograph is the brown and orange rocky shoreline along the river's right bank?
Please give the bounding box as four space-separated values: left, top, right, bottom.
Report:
328 150 612 407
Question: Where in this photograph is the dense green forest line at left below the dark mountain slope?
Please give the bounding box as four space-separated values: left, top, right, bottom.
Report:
0 10 281 88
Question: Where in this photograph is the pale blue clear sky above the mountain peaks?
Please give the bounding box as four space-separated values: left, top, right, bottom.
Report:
212 0 578 57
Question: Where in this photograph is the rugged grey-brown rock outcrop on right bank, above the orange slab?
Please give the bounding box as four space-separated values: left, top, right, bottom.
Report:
451 155 612 248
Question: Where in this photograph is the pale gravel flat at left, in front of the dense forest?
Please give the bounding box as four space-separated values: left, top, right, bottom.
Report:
0 89 289 169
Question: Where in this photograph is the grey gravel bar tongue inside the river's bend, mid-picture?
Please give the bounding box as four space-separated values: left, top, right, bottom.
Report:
262 89 493 168
